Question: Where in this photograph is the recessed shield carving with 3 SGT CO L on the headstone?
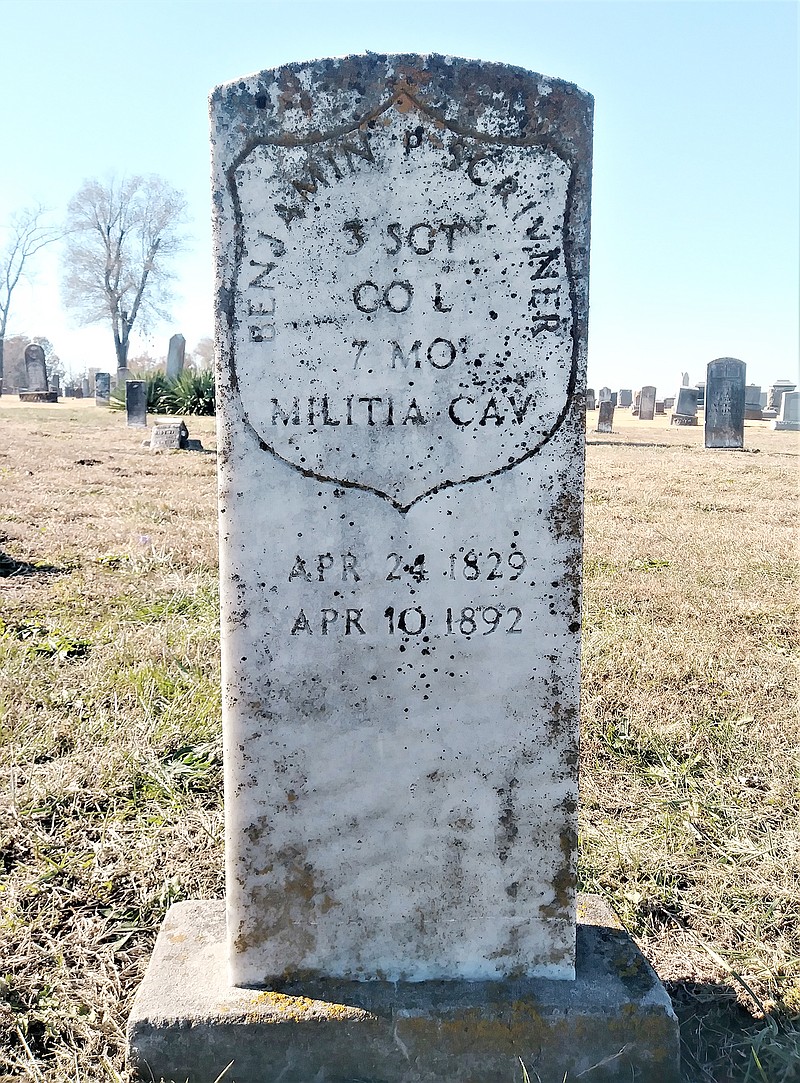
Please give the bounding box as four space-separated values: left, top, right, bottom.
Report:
228 86 576 511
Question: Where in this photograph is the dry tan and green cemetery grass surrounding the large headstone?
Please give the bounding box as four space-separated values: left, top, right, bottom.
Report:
0 397 800 1083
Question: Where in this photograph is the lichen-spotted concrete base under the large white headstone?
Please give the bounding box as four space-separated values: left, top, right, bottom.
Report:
128 896 679 1083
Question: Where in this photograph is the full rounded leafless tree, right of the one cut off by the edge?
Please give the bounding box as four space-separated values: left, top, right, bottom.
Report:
63 177 186 368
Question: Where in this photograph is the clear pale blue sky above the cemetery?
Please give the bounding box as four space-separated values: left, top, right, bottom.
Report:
0 0 799 394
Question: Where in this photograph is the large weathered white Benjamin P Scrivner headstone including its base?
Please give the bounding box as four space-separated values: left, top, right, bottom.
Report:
130 55 677 1083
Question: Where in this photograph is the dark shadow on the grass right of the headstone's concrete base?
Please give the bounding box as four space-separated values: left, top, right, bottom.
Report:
665 981 800 1083
